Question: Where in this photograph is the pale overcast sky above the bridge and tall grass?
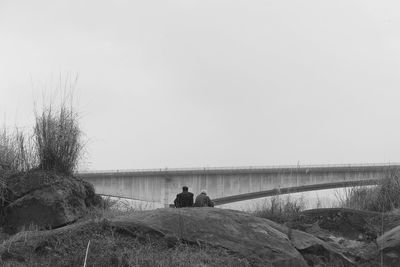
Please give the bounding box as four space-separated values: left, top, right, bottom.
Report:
0 0 400 170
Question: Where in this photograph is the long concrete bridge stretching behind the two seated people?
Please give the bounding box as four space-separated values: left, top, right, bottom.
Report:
78 164 400 206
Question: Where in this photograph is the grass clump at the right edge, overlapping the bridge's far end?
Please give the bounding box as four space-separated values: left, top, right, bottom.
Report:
338 171 400 212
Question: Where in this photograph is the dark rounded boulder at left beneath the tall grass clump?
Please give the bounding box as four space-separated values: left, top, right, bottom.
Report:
1 170 101 233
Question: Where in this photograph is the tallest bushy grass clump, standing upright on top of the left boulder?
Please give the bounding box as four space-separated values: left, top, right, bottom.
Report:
33 104 83 174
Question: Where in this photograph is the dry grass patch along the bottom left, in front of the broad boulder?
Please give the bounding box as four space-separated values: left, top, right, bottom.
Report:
0 222 250 267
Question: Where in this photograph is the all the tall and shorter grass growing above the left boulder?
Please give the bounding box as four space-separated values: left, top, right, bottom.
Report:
0 92 83 174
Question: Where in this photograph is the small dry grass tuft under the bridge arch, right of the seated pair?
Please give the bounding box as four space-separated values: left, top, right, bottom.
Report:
252 195 306 223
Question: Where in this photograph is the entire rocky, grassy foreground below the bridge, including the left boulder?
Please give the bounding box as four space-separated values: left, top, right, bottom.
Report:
0 171 400 267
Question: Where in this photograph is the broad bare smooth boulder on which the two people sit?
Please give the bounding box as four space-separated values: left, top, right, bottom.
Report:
111 208 308 266
